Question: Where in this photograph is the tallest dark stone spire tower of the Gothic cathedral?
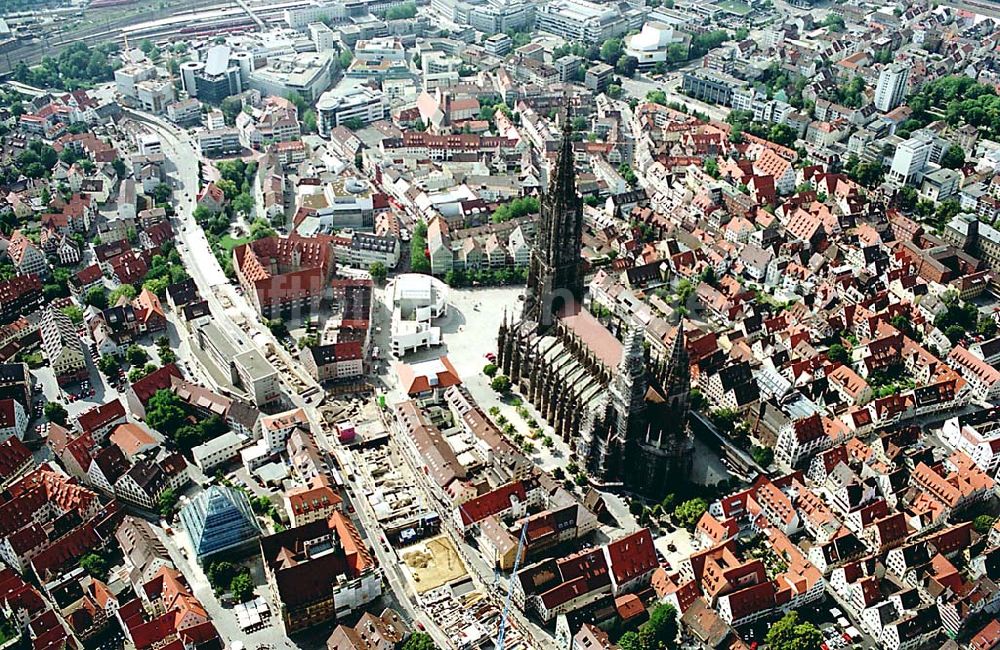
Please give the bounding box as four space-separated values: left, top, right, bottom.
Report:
524 128 584 331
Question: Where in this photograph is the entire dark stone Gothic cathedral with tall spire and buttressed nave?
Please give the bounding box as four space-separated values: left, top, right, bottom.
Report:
497 126 693 498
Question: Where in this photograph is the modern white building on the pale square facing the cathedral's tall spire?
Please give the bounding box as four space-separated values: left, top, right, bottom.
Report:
391 273 448 357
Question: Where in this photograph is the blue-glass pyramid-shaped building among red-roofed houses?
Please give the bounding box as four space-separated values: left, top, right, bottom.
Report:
181 485 260 562
